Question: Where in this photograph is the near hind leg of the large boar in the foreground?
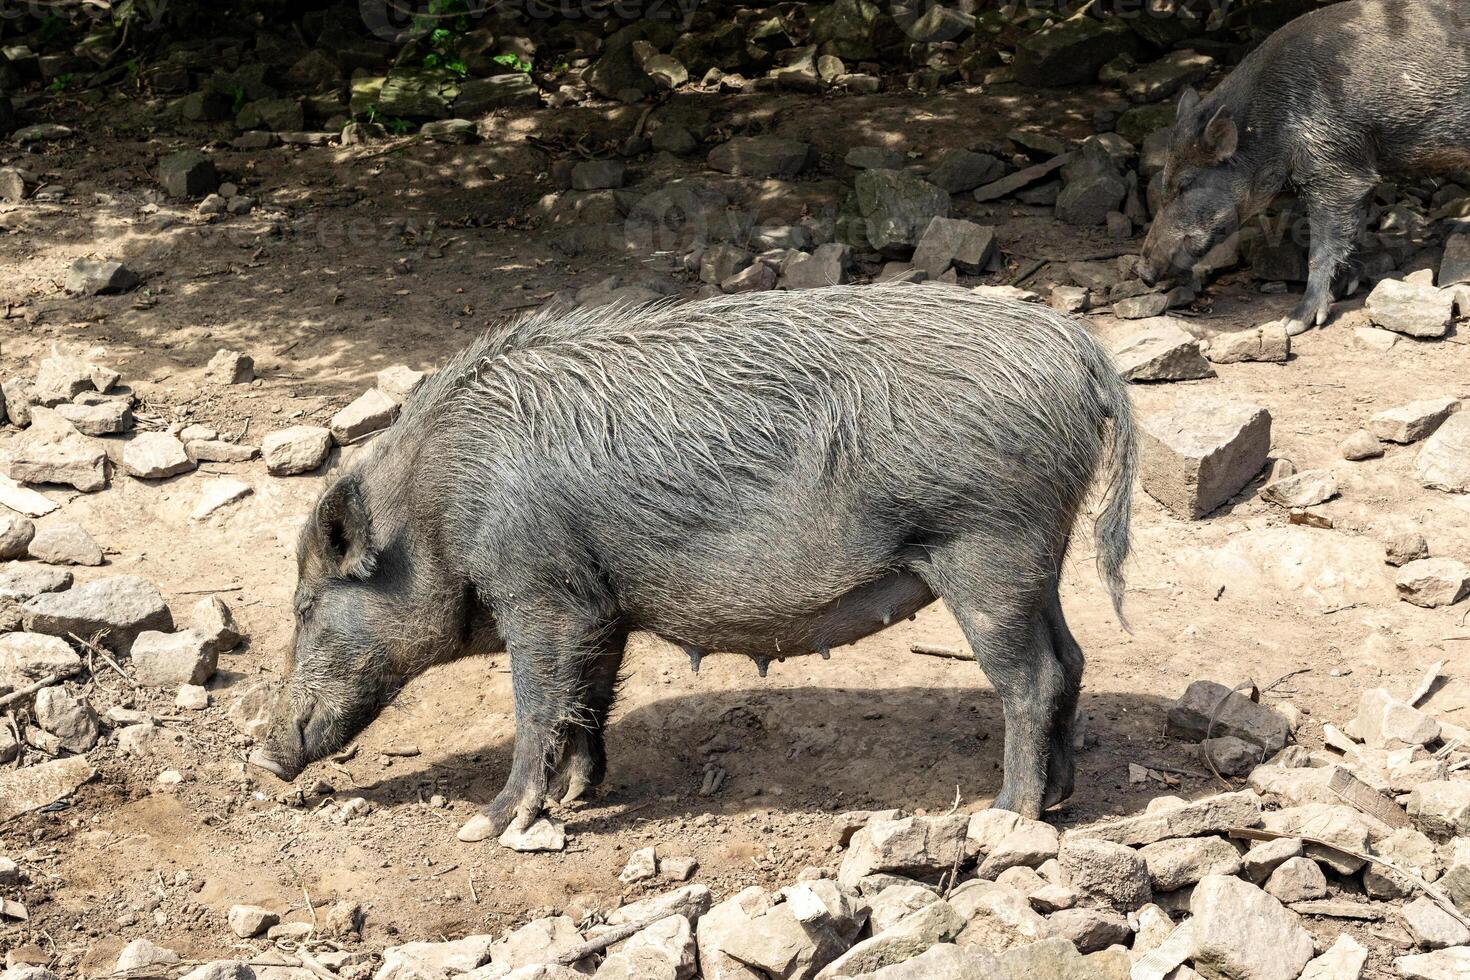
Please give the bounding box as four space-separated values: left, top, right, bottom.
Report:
922 544 1067 820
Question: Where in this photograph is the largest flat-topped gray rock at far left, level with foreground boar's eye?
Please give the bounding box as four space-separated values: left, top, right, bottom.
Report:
21 574 173 652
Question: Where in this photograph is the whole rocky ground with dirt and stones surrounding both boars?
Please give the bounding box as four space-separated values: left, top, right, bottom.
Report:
0 0 1470 980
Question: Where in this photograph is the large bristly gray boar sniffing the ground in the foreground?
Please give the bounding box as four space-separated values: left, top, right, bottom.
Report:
251 284 1135 840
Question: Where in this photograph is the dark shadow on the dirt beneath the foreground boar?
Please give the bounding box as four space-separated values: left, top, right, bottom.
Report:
361 687 1187 832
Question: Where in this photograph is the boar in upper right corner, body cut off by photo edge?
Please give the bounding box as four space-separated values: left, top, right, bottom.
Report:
1141 0 1470 334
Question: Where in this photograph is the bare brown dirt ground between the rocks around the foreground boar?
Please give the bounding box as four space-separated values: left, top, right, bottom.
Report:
0 85 1470 973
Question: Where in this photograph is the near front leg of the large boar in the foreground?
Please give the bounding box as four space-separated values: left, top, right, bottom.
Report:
457 605 604 842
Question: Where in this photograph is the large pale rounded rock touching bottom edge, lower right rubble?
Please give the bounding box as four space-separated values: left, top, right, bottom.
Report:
1189 874 1314 980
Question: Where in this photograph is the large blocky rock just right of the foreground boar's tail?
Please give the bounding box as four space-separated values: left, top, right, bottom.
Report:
1139 400 1272 520
